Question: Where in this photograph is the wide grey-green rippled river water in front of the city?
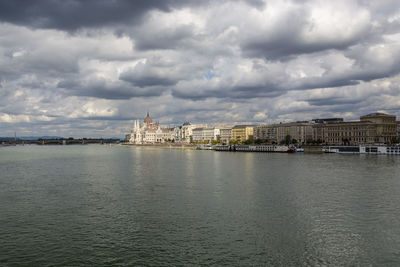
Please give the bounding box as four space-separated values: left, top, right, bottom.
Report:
0 145 400 266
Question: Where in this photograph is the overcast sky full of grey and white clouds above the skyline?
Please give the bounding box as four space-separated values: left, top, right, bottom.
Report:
0 0 400 137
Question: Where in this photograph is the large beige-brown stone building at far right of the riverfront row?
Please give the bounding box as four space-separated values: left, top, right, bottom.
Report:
313 113 397 145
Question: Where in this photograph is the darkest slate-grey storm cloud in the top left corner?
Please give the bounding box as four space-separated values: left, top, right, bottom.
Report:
0 0 194 31
